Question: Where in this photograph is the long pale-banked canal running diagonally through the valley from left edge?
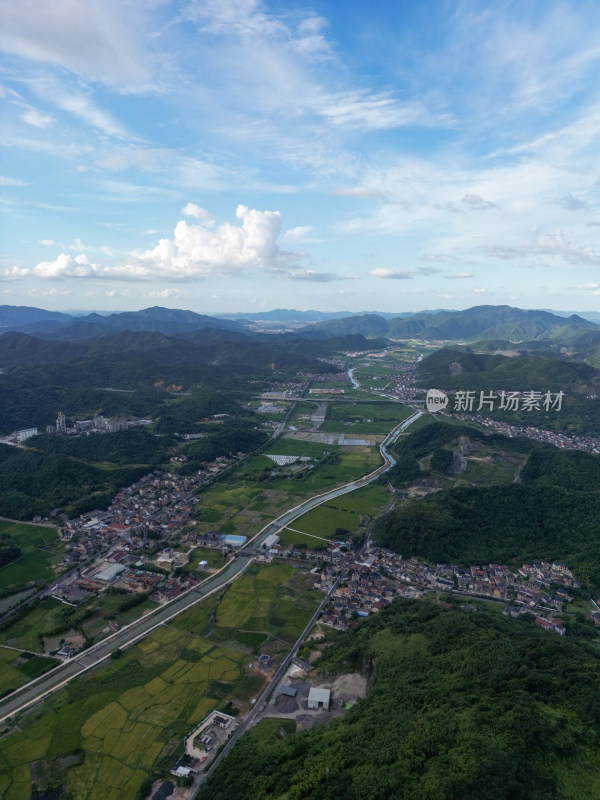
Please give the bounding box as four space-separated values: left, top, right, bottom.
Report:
0 411 423 722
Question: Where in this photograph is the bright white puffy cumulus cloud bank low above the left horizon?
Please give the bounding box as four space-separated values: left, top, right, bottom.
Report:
11 204 304 280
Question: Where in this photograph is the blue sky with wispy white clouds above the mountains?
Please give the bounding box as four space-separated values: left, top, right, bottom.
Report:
0 0 600 313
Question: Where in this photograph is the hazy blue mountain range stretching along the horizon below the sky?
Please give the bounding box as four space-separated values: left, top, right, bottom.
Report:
0 305 600 350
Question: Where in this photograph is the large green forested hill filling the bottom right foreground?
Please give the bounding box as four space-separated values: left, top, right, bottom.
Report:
200 600 600 800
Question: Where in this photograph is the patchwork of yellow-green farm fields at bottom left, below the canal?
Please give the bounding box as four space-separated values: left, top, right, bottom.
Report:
0 564 320 800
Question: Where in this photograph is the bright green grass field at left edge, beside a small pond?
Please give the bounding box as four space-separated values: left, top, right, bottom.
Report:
0 522 64 592
